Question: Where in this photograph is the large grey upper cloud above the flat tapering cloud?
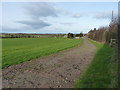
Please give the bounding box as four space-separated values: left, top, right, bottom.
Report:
25 2 58 18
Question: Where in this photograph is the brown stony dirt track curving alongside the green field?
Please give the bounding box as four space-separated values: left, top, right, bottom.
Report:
3 39 96 88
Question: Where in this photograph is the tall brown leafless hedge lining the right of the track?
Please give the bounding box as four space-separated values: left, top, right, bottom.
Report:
88 20 118 44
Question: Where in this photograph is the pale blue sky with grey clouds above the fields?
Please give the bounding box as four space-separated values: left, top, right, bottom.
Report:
0 2 118 33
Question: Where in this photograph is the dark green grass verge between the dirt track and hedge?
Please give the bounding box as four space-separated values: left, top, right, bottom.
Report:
76 39 118 88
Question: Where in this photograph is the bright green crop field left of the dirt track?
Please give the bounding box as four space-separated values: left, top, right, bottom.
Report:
2 38 83 68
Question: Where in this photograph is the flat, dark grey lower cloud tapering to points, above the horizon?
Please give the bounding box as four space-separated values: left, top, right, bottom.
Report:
16 20 51 29
